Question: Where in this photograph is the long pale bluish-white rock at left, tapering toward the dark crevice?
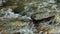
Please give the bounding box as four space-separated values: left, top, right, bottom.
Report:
0 8 31 21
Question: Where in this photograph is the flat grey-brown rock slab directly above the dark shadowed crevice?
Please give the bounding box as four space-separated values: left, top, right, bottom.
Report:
32 13 55 20
